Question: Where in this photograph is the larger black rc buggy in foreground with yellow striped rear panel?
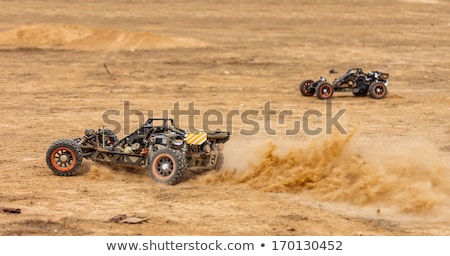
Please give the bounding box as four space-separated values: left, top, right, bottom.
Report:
46 118 230 185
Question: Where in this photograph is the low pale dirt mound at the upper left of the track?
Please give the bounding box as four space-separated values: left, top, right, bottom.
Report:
0 24 207 51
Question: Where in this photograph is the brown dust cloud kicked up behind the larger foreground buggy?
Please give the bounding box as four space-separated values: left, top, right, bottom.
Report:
205 130 450 217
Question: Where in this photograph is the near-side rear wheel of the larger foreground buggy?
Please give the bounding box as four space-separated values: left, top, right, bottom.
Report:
149 148 187 185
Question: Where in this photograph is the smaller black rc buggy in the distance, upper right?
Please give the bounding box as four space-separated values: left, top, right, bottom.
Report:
299 68 389 100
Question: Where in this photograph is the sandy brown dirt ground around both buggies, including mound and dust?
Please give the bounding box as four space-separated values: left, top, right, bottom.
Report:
0 0 450 236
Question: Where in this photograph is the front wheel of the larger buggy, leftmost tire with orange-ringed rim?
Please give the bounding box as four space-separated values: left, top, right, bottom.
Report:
46 139 83 176
